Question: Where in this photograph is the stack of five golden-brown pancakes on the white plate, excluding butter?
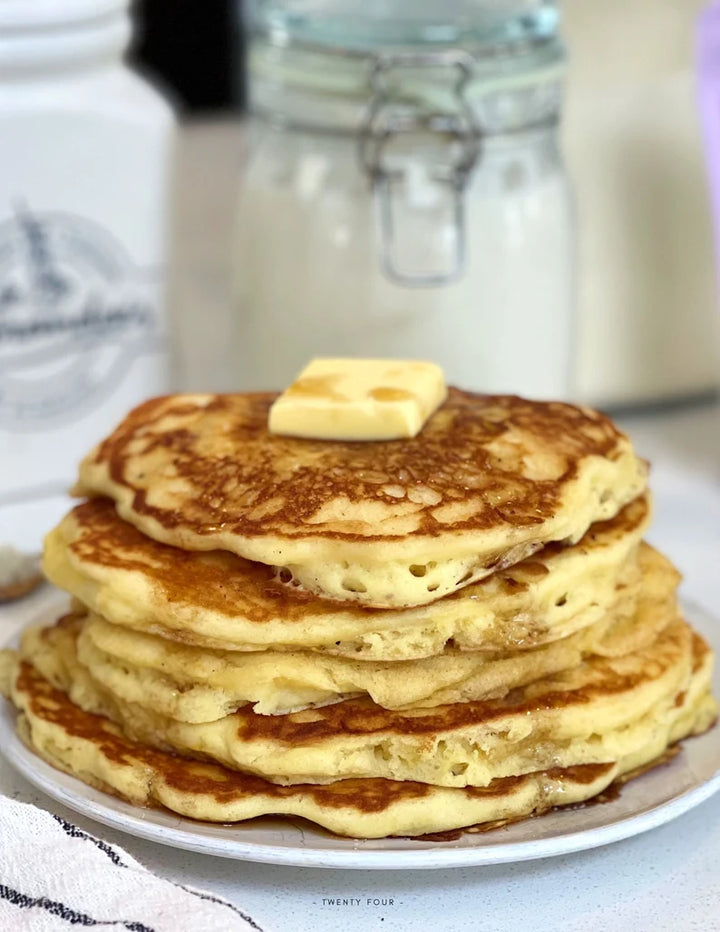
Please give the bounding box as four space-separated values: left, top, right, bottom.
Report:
0 389 716 837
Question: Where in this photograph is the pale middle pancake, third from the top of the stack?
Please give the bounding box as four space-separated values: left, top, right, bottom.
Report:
33 548 677 722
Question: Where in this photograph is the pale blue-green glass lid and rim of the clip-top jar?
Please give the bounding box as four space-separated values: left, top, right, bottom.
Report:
248 0 565 133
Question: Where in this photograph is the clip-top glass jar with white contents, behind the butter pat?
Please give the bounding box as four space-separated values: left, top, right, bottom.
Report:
235 3 573 397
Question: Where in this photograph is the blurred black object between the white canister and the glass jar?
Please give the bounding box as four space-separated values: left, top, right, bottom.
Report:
132 0 245 112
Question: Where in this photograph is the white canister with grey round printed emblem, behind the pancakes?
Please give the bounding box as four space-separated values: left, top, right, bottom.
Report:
0 0 174 503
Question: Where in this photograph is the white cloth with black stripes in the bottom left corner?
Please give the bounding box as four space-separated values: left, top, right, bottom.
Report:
0 796 262 932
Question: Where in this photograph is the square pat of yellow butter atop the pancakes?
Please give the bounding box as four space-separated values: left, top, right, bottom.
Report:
269 359 447 440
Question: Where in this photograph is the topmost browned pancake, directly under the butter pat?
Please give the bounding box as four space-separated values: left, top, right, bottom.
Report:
76 389 646 608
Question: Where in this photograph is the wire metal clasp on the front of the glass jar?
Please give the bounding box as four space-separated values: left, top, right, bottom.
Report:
359 49 482 287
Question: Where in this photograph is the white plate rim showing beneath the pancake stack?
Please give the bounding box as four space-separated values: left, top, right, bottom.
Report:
0 590 720 870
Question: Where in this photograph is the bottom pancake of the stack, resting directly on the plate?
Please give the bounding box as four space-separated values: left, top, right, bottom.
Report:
0 644 715 838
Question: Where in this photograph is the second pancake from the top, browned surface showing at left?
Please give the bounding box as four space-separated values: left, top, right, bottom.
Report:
44 496 652 661
